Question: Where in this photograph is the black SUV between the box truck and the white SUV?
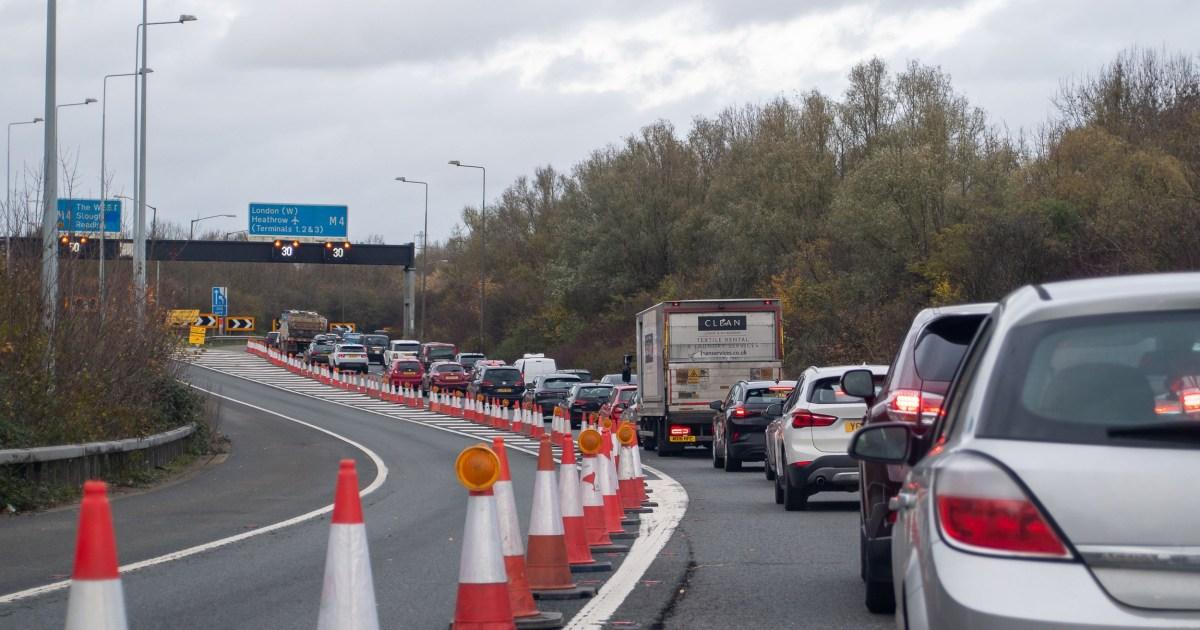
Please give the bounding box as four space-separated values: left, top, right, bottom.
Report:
708 380 796 472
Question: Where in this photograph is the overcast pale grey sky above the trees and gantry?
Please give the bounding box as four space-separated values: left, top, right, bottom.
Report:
0 0 1200 242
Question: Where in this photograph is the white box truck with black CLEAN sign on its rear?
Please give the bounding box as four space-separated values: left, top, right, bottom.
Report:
635 299 784 455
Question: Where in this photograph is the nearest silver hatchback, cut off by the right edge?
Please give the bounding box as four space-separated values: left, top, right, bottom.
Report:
842 274 1200 630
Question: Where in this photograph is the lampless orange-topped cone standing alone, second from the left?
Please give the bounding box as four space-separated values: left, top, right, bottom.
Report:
317 460 379 630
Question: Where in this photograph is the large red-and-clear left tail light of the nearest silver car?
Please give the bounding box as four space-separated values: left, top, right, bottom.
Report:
934 455 1072 558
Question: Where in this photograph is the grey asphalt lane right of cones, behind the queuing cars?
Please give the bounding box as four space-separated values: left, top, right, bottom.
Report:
613 450 895 629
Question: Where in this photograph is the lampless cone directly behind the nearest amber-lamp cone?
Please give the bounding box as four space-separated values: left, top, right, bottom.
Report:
492 437 563 628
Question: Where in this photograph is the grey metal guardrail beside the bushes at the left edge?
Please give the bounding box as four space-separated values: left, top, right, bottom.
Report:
0 425 196 485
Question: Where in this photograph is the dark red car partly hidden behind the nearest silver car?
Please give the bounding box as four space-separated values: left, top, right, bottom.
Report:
841 304 996 613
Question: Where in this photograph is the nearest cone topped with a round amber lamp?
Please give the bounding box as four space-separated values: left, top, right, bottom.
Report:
450 444 516 630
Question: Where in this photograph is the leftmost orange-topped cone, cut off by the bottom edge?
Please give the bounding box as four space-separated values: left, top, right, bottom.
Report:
66 481 126 630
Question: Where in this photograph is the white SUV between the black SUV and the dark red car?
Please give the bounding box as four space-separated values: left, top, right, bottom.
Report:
764 365 888 511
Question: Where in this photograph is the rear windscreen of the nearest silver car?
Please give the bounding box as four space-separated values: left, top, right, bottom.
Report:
979 311 1200 448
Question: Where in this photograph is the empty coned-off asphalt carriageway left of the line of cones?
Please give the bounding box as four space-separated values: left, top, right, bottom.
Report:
0 360 582 629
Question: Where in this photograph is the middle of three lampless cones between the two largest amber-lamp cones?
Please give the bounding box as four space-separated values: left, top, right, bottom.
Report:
526 437 595 599
